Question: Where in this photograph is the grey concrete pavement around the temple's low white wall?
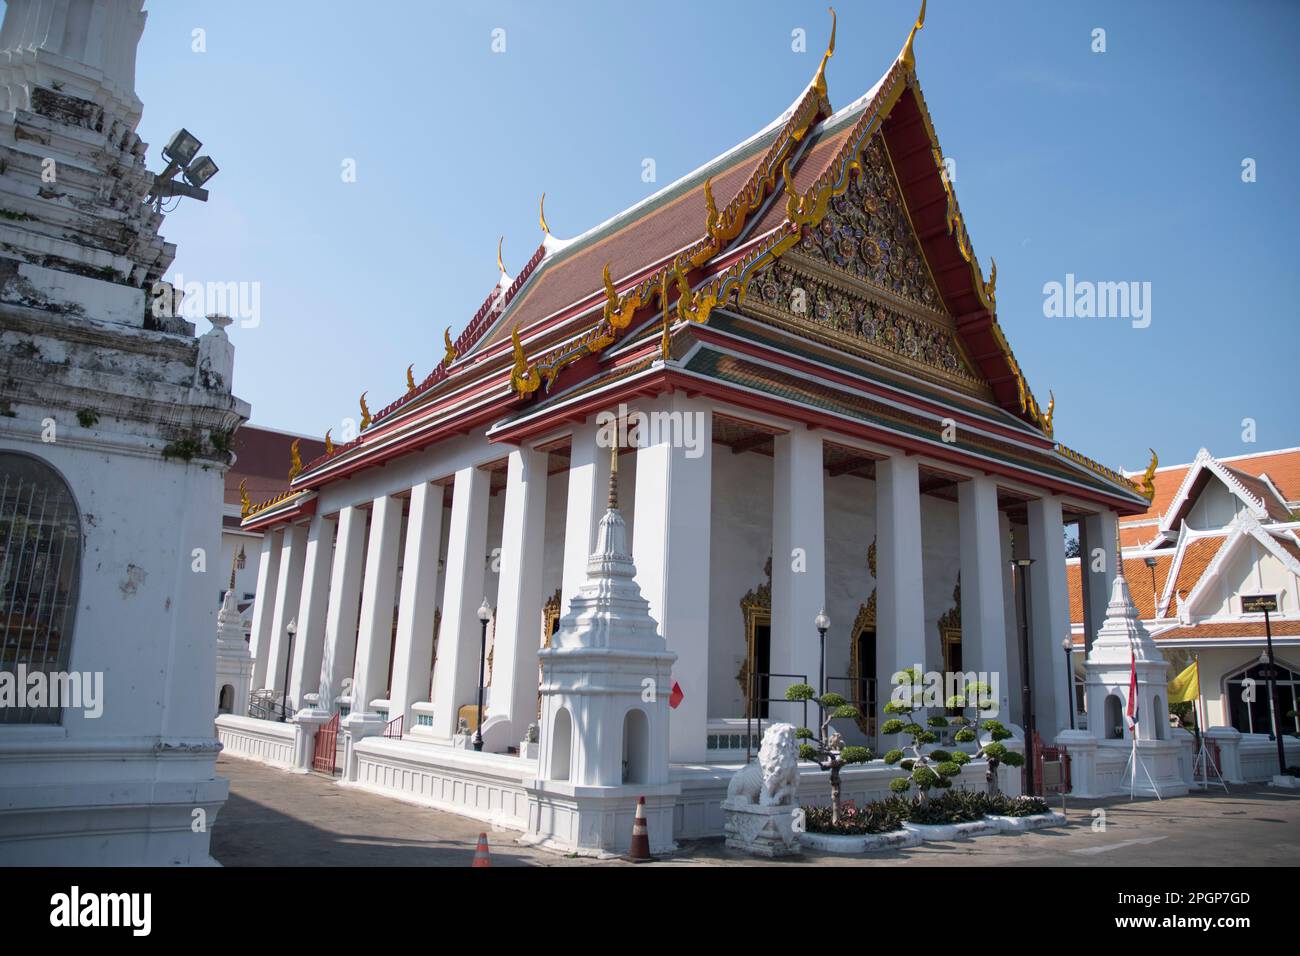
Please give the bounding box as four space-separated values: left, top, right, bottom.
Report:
212 757 1300 866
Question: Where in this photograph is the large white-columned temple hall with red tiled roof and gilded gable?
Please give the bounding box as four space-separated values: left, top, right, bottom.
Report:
218 9 1149 836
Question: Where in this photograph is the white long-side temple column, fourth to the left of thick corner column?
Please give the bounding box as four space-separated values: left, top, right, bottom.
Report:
389 481 442 732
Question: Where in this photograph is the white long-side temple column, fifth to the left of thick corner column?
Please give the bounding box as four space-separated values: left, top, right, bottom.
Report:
348 494 402 723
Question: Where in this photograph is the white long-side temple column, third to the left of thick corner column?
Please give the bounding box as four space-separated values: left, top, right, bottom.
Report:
433 467 490 740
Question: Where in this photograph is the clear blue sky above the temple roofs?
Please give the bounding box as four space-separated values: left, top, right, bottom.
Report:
83 0 1300 468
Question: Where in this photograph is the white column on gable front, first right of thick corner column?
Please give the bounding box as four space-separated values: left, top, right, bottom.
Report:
768 425 821 702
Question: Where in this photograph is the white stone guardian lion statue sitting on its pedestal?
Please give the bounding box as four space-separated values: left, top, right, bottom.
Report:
723 723 800 857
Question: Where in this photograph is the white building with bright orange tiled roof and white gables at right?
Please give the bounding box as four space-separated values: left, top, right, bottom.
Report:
1067 449 1300 738
